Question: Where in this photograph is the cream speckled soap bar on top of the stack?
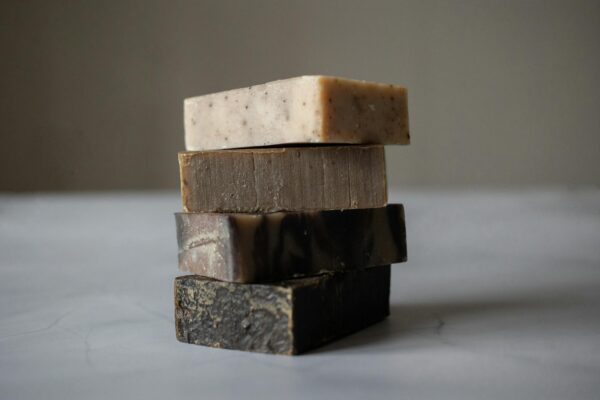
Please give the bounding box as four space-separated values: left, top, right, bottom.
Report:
184 76 410 150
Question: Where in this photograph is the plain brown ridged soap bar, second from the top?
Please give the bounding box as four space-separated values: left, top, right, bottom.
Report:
179 145 387 212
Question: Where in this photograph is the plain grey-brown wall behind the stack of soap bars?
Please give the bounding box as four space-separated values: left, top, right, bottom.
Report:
0 0 600 190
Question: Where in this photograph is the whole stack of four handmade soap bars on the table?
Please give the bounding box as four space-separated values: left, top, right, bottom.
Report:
175 76 409 354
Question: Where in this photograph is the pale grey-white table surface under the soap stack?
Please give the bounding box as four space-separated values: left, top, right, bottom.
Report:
0 189 600 400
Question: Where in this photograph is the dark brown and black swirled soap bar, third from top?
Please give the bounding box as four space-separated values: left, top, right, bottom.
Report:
176 204 406 283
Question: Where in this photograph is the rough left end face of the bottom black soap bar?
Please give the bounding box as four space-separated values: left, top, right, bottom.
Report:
175 276 293 354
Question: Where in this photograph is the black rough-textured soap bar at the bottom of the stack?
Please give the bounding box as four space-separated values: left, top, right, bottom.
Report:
175 265 390 354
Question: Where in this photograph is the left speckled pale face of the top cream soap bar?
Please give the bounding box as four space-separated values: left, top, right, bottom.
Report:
184 76 322 150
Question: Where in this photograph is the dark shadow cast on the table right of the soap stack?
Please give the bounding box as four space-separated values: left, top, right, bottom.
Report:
310 292 578 354
